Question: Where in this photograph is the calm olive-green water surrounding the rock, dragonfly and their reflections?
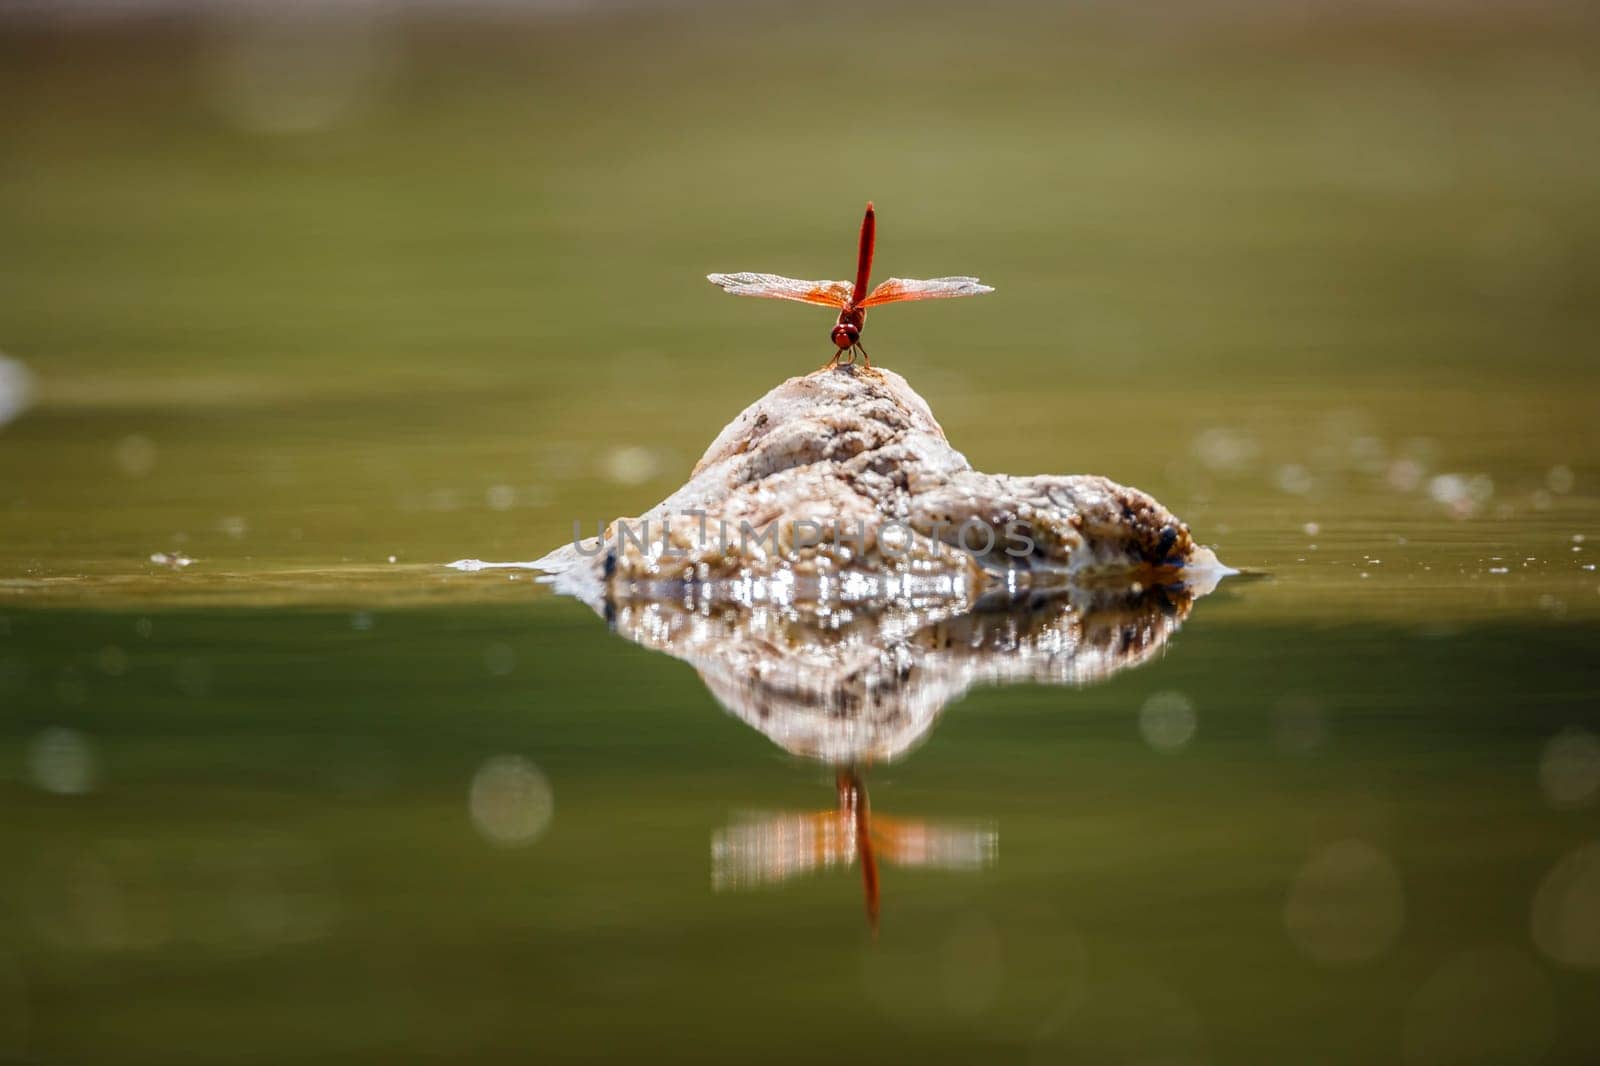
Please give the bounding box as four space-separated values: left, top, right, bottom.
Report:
0 6 1600 1063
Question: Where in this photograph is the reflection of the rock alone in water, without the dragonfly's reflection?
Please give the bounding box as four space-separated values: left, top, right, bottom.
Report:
603 584 1197 767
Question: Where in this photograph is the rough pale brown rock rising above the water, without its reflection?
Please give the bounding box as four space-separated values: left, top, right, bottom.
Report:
536 365 1222 603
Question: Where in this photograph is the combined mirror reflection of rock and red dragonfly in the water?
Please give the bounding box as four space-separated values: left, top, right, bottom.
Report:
572 569 1213 930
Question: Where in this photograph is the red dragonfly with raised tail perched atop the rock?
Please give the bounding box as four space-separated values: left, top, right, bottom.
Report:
706 200 995 367
